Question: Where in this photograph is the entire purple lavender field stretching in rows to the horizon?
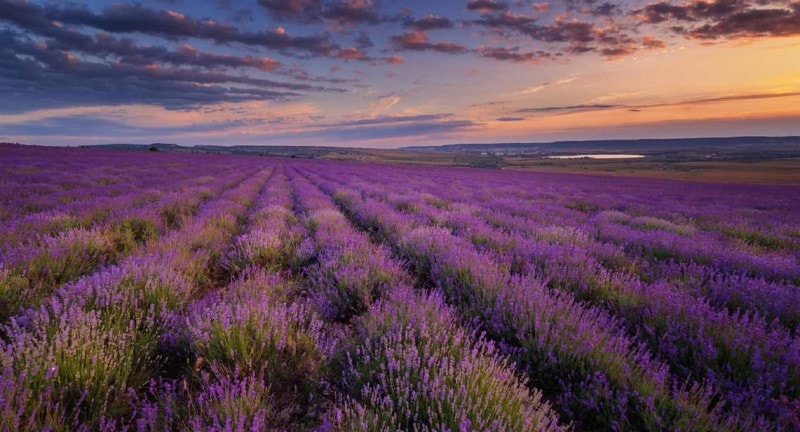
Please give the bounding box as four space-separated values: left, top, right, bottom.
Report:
0 145 800 432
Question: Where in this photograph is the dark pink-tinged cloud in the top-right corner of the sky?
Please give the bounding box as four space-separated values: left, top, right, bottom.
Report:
633 0 800 39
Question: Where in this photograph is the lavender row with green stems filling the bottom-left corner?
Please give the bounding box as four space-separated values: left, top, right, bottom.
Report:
0 165 269 430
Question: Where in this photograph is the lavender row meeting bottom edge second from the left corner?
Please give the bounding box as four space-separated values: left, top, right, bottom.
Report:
133 167 328 431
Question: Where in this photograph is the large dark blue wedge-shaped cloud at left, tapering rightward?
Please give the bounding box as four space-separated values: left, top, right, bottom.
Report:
0 31 340 112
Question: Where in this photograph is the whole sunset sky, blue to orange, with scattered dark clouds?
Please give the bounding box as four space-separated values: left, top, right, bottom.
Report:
0 0 800 148
